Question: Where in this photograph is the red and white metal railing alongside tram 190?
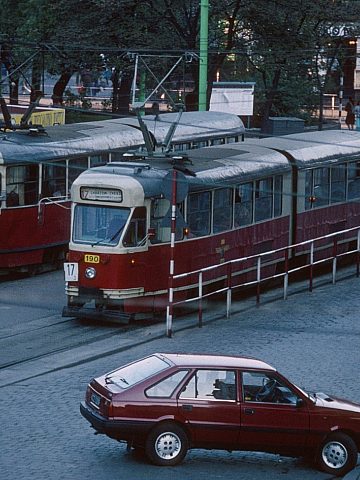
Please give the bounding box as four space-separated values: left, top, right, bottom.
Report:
167 226 360 334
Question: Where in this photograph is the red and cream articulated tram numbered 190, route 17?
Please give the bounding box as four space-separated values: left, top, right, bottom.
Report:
63 131 360 320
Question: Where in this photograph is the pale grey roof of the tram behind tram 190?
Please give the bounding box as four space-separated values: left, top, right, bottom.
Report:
0 112 245 164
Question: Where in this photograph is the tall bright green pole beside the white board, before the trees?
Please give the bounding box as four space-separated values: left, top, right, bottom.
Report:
199 0 209 111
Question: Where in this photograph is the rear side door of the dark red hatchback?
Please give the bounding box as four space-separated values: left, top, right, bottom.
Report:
178 369 240 448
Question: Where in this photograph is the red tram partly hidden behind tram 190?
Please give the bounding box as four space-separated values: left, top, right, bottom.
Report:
0 112 245 274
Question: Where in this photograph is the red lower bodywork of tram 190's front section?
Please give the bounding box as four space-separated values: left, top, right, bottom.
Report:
68 216 290 316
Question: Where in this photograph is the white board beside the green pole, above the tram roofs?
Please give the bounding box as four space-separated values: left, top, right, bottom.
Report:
210 82 255 116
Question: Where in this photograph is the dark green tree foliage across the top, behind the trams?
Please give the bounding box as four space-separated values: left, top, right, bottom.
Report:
0 0 360 124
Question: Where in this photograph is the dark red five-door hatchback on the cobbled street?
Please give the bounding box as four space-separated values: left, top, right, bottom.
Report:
80 353 360 476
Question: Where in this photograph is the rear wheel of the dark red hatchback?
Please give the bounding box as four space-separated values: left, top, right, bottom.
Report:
145 422 189 466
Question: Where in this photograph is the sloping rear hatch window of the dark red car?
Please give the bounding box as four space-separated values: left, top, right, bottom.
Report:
105 355 169 389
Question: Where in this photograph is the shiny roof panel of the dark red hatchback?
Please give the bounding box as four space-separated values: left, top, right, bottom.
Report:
156 353 276 371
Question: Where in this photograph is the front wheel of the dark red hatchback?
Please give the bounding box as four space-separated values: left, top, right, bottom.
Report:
318 433 358 477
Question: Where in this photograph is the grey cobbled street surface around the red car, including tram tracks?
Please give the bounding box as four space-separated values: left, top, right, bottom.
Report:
0 272 360 480
